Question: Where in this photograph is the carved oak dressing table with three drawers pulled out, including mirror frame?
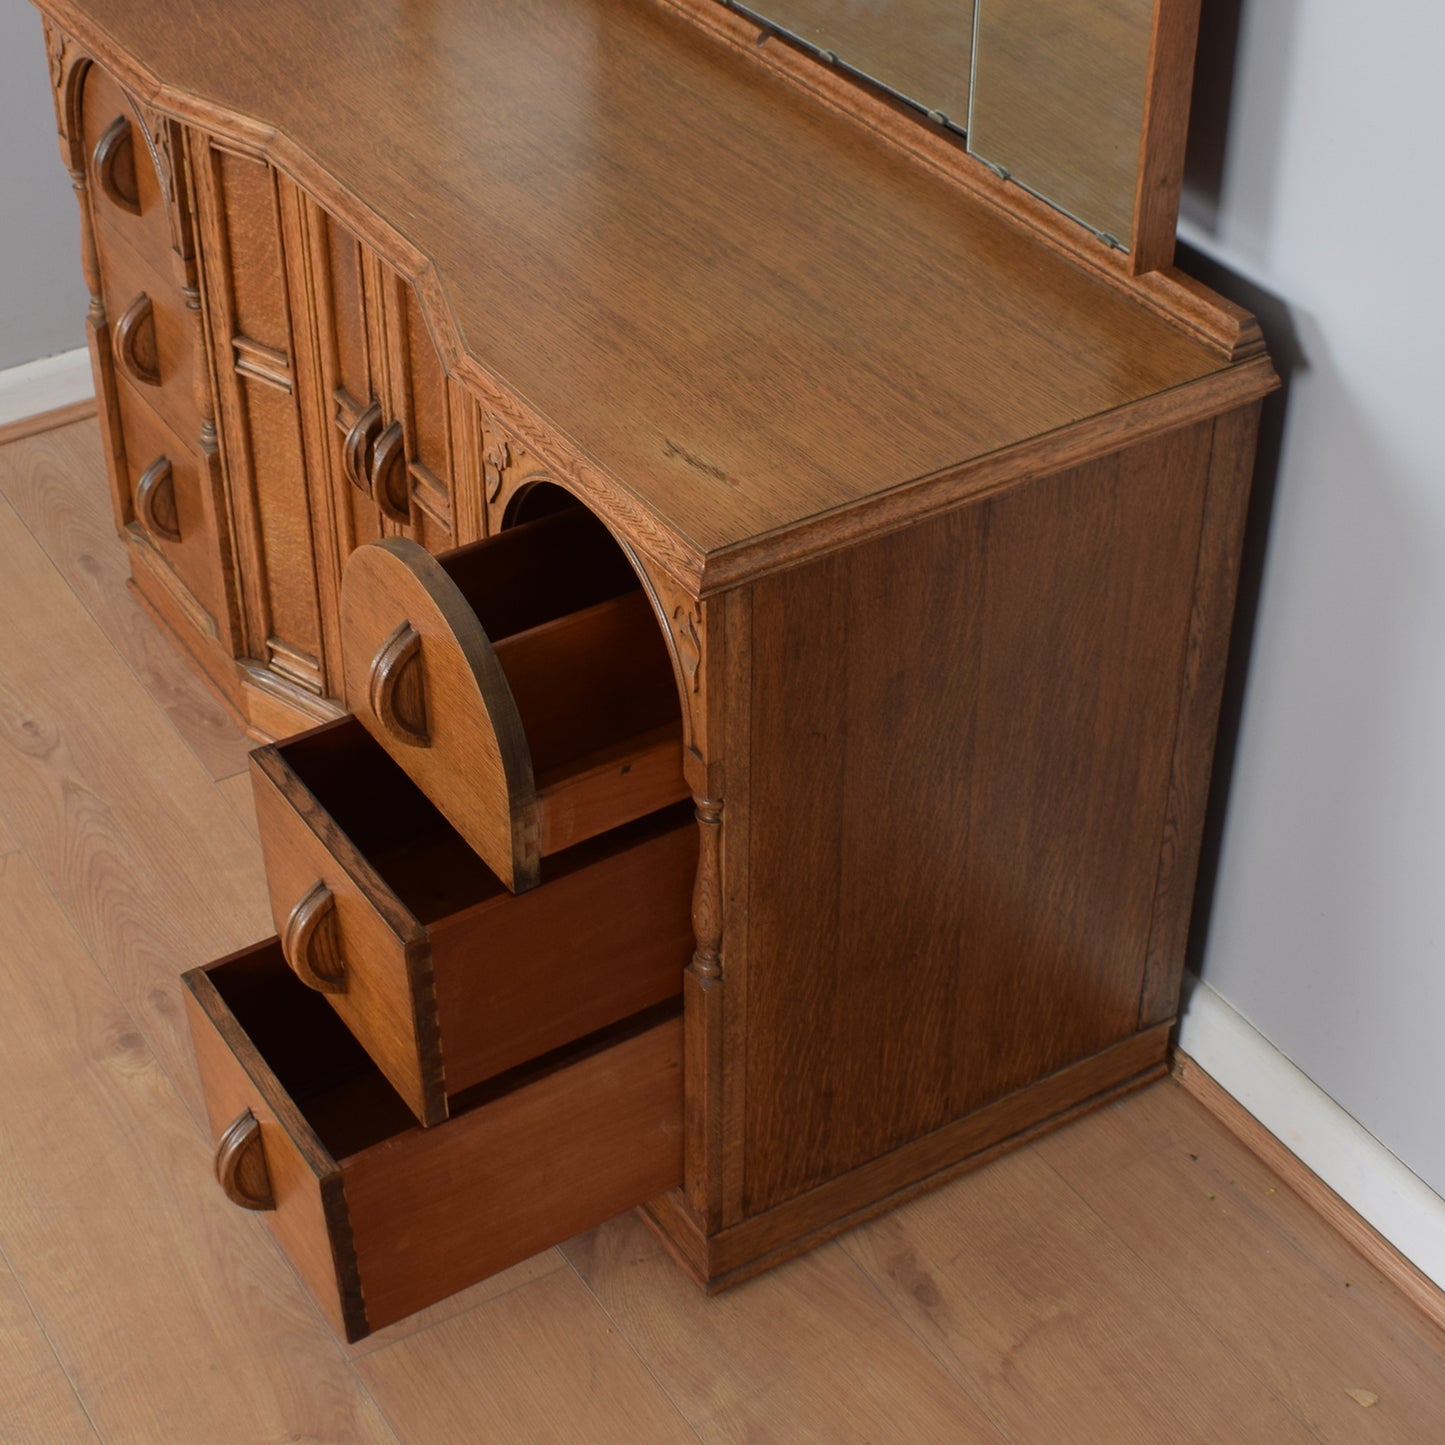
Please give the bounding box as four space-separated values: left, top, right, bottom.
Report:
33 0 1274 1338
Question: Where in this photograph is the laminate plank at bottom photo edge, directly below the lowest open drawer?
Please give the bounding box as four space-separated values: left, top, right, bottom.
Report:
357 1269 696 1445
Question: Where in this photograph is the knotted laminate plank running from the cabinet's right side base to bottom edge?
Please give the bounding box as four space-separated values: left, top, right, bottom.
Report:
841 1149 1315 1445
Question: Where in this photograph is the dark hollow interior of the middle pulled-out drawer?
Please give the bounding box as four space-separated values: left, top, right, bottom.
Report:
277 717 691 926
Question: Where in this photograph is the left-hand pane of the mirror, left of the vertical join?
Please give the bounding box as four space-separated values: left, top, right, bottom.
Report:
734 0 974 130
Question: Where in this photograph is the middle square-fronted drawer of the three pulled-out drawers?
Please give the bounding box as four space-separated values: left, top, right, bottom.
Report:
251 718 698 1124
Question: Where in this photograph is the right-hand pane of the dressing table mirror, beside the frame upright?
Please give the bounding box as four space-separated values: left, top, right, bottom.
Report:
968 0 1155 247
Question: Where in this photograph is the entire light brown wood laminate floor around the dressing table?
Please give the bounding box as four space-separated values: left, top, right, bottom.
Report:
8 422 1445 1445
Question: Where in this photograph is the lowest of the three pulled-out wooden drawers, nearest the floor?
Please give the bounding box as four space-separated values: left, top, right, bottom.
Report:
184 941 682 1340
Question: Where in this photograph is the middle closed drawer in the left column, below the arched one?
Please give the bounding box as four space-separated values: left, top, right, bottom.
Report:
101 228 201 445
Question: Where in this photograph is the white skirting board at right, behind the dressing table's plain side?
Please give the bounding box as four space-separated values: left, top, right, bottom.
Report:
1179 974 1445 1289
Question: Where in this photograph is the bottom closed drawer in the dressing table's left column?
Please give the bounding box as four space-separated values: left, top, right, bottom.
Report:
116 384 223 621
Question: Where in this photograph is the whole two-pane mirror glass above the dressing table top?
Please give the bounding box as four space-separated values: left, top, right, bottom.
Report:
734 0 1156 250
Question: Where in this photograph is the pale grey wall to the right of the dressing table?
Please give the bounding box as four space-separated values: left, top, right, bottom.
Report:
1185 0 1445 1194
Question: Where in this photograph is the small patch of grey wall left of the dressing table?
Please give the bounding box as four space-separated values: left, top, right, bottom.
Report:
0 0 87 370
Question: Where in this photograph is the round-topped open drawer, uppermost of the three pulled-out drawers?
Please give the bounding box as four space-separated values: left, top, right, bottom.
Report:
341 506 686 892
